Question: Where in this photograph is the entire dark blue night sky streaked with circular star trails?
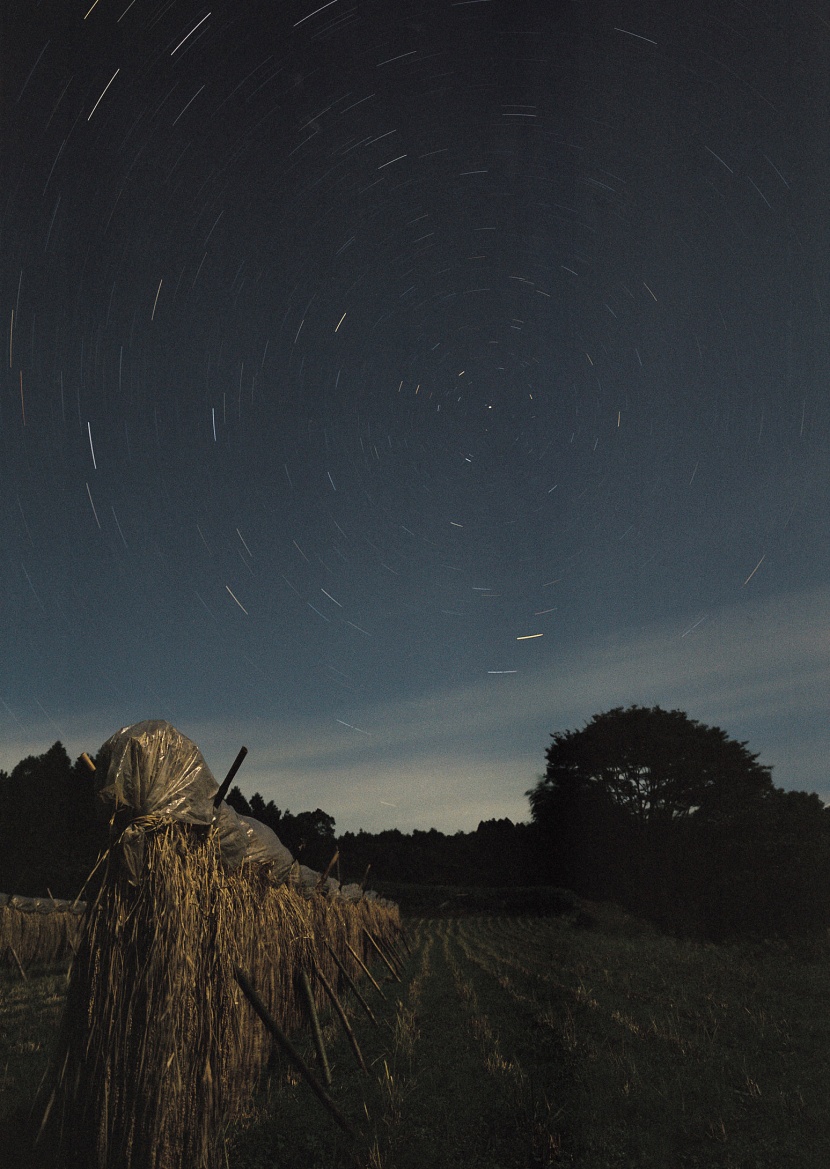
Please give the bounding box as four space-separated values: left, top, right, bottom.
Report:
0 0 830 831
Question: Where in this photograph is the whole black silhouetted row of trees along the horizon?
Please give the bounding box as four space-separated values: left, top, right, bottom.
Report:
0 706 830 939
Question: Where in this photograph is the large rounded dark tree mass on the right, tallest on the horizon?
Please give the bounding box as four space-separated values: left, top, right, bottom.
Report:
527 706 830 938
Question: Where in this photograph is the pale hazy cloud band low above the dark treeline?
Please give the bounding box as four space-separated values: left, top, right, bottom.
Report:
0 590 830 831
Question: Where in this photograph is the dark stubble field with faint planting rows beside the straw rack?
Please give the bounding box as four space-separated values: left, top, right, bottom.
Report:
0 907 830 1169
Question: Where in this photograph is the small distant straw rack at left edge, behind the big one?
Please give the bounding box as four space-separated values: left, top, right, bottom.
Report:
0 893 85 970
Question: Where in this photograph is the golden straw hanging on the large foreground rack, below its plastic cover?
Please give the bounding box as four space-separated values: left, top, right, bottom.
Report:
42 720 399 1169
